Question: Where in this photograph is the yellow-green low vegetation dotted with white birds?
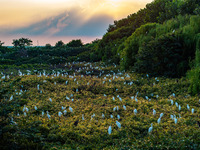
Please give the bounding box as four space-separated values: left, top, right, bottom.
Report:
0 63 200 149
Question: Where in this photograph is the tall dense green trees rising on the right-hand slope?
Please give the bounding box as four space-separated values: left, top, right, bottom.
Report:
92 0 200 77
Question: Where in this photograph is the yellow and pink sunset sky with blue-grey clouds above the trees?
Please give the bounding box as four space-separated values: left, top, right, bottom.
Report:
0 0 152 46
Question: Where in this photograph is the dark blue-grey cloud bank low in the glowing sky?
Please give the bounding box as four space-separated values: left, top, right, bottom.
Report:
6 9 113 36
